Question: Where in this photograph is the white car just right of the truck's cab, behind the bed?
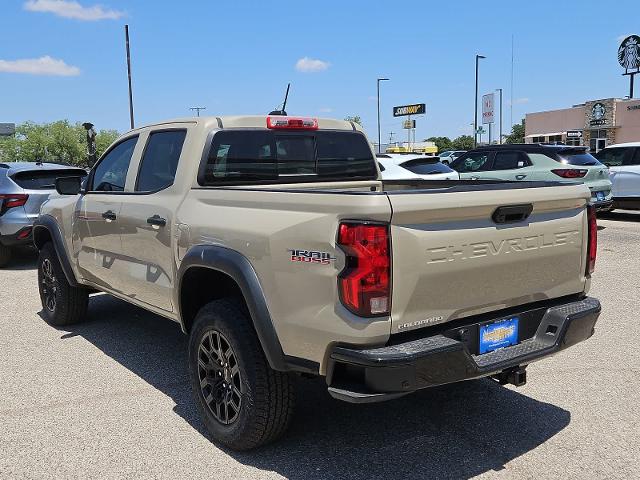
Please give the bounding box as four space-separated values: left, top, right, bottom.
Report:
377 153 460 180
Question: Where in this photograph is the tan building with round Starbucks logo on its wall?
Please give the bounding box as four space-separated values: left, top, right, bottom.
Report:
525 98 640 152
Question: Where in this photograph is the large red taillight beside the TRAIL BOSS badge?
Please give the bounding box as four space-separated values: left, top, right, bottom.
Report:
338 222 391 317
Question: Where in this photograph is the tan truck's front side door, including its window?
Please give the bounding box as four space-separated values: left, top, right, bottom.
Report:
73 135 138 291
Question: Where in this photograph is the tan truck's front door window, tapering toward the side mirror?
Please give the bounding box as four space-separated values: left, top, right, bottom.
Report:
90 136 138 192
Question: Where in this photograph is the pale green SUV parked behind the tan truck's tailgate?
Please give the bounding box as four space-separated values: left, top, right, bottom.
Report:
450 143 613 210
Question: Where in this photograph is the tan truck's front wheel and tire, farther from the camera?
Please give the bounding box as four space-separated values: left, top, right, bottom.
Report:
38 243 89 326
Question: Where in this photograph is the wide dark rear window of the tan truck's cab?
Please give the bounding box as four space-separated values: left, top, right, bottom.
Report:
200 130 378 185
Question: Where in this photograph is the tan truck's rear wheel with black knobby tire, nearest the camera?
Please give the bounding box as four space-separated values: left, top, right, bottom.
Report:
189 299 295 450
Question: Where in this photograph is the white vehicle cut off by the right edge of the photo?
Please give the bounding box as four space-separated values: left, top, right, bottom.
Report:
594 142 640 209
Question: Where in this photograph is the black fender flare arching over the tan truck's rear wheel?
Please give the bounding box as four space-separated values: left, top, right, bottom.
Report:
174 245 319 374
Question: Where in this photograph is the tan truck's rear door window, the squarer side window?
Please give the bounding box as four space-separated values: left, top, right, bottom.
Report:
136 130 187 192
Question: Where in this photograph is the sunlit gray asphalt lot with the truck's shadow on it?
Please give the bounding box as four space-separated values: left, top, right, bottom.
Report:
0 212 640 480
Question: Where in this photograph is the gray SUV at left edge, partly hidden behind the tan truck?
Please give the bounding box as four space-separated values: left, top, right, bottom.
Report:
0 162 87 267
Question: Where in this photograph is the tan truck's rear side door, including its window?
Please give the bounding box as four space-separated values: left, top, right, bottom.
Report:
120 128 187 312
